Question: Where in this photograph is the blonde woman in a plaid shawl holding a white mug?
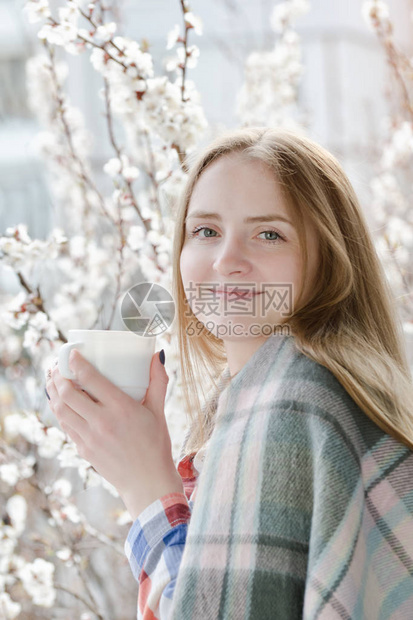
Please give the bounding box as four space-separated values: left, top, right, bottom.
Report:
46 128 413 620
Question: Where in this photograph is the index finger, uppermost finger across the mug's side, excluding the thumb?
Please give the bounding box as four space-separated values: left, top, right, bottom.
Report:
70 349 125 405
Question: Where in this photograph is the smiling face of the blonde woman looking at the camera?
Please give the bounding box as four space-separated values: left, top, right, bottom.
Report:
180 153 317 341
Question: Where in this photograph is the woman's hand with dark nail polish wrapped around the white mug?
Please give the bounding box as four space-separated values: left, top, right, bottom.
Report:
46 349 184 520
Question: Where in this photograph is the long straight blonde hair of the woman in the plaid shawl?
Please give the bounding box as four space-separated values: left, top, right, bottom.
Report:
173 127 413 454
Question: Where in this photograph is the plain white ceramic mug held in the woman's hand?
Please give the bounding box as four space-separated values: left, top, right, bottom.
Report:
58 329 156 401
